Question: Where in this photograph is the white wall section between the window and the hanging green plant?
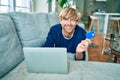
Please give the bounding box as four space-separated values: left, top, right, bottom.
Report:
33 0 48 12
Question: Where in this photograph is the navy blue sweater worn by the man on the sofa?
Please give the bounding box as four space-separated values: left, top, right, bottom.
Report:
44 24 86 53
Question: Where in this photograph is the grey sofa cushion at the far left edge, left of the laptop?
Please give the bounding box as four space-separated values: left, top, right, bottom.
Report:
0 15 24 77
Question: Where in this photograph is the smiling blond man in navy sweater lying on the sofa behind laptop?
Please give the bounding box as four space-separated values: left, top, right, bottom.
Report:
44 8 91 60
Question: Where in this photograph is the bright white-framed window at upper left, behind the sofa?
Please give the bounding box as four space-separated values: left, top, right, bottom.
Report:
0 0 32 13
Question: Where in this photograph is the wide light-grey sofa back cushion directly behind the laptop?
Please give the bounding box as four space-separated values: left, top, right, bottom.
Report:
9 12 50 47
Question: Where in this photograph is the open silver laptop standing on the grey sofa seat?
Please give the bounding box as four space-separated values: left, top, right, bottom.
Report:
23 47 68 74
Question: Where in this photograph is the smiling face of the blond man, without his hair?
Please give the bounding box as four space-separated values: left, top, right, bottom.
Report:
60 18 78 34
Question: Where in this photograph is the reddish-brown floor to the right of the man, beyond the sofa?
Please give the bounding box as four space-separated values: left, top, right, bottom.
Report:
88 34 119 62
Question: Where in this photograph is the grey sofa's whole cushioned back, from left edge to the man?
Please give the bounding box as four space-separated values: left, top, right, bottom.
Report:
0 12 59 77
